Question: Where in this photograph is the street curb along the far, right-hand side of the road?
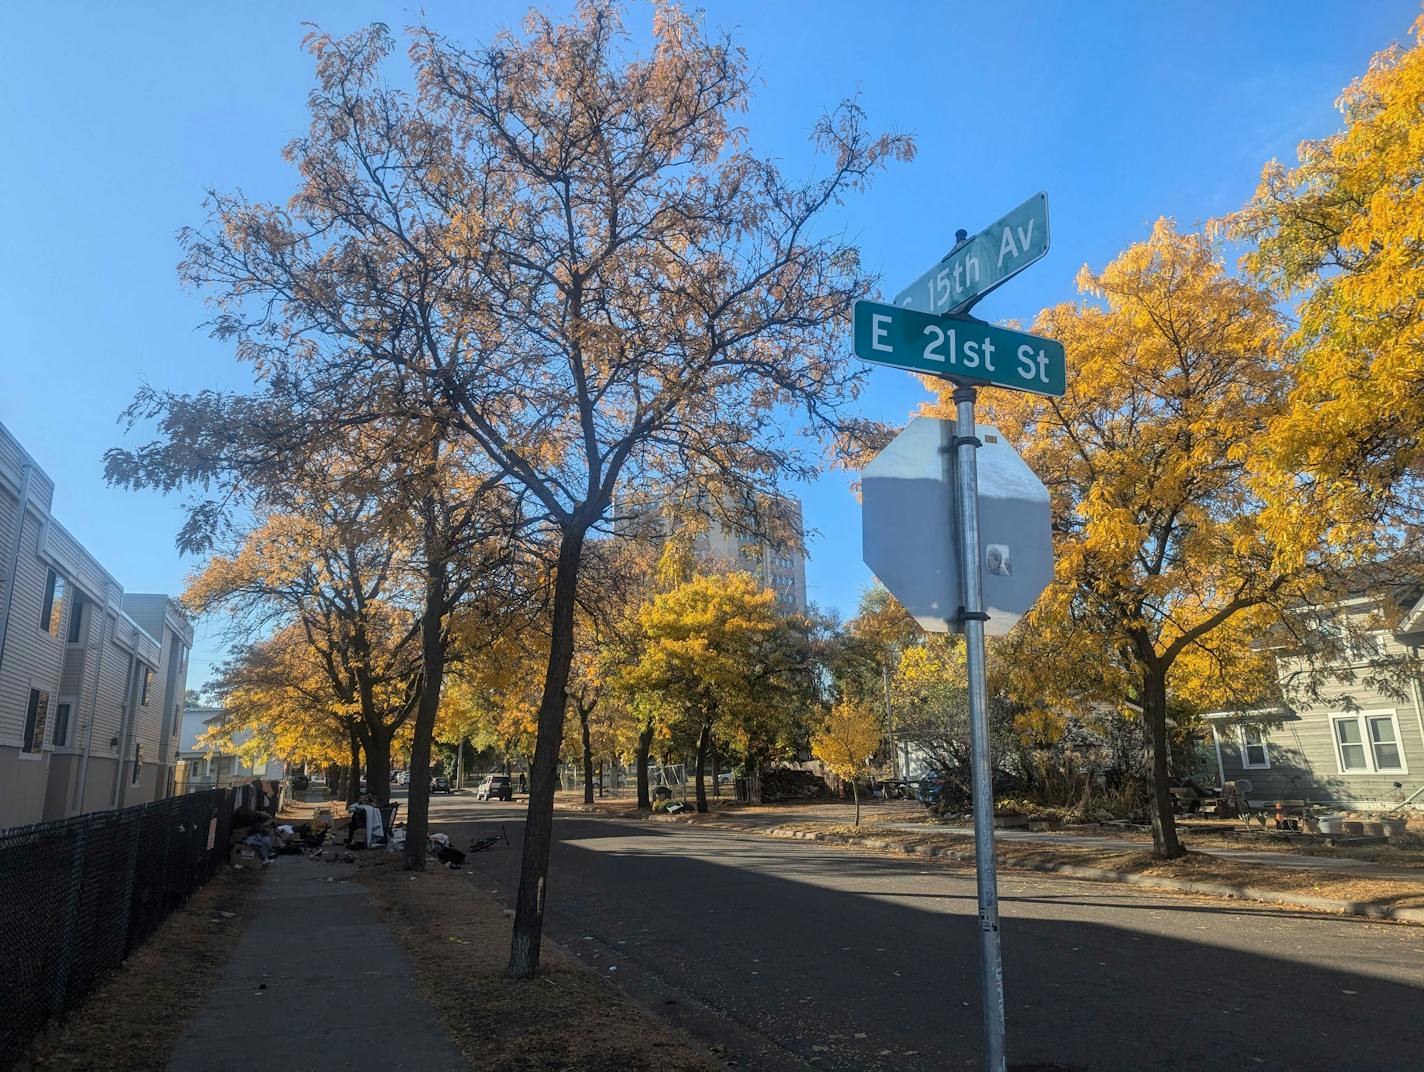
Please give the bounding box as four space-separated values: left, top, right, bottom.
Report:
757 824 1424 924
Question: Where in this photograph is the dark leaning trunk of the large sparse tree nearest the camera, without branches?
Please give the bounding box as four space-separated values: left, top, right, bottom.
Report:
508 528 584 979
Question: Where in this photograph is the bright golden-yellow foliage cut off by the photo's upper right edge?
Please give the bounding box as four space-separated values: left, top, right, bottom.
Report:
1229 17 1424 560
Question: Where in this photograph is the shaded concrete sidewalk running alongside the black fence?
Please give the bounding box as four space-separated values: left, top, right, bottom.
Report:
168 856 468 1072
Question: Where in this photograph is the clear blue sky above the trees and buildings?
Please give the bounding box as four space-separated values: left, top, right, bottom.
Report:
0 0 1420 685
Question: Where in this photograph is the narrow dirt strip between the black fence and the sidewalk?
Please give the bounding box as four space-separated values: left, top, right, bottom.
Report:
24 868 262 1072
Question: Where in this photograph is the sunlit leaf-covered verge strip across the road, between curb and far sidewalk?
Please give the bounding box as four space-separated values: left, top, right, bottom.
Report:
778 823 1424 908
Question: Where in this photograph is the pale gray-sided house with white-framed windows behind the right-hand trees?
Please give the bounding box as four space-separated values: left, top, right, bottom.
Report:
1206 598 1424 810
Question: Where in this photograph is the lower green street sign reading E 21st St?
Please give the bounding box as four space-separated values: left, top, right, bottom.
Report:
854 302 1068 399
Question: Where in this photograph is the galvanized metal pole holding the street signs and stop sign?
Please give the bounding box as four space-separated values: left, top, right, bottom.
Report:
953 386 1005 1072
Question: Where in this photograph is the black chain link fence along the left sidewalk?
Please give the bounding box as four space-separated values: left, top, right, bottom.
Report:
0 789 232 1069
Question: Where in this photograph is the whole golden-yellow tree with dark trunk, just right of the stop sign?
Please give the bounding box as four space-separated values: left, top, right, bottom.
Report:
922 221 1321 857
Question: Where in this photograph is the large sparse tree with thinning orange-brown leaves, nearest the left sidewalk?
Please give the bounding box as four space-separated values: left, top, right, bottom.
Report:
131 0 913 977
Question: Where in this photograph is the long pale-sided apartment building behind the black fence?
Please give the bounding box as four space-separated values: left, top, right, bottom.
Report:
0 424 192 829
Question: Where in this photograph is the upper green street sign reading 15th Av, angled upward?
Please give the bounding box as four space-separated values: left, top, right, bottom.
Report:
894 194 1048 315
